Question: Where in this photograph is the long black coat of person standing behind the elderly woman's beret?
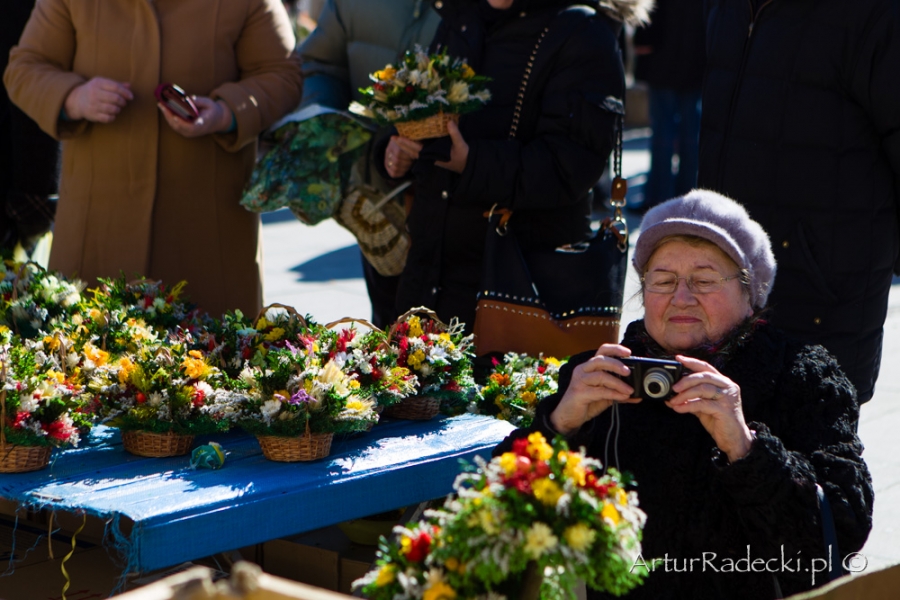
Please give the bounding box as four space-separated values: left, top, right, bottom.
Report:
698 0 900 402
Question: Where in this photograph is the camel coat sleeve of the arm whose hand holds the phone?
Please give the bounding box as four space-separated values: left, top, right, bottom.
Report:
211 0 302 152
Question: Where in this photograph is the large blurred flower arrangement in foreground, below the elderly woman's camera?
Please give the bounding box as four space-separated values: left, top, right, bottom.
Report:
353 433 645 600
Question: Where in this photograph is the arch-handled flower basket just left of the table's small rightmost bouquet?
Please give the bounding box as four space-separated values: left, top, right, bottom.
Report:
385 307 474 420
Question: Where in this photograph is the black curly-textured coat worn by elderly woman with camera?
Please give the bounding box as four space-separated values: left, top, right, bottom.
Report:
494 321 873 600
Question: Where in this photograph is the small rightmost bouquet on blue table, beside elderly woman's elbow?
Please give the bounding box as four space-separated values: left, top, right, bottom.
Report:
475 352 562 427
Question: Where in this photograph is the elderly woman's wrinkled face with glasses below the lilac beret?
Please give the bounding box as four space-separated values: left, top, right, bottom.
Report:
643 240 753 353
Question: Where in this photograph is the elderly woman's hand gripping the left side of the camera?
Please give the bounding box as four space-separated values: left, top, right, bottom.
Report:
550 344 641 436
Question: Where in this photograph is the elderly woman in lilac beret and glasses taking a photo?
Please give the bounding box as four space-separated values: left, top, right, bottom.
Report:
497 191 873 600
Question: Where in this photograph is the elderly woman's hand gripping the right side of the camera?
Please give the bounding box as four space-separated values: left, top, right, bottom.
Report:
666 356 753 462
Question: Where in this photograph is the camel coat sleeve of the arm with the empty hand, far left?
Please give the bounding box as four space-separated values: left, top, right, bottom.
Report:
3 0 88 139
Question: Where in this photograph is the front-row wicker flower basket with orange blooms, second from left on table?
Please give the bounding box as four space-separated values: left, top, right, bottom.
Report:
81 332 243 457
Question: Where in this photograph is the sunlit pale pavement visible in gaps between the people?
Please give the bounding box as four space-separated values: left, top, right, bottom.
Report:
263 130 900 572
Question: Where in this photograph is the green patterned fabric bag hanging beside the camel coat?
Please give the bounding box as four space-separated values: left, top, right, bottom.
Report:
241 104 372 225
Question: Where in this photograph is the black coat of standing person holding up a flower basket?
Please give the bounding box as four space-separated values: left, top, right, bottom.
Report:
397 0 645 328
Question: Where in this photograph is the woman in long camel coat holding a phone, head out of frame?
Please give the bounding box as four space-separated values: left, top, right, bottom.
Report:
4 0 301 316
